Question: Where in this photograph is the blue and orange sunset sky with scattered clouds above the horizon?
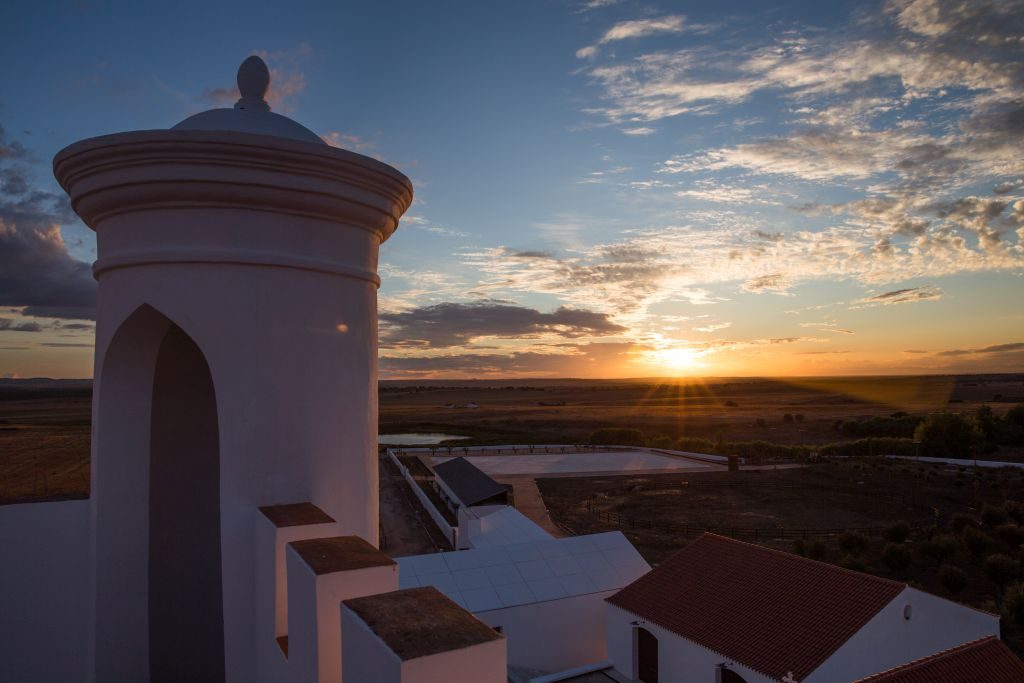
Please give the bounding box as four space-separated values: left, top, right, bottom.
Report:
0 0 1024 378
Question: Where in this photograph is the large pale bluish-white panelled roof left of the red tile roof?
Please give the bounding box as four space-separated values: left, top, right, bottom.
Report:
397 531 650 612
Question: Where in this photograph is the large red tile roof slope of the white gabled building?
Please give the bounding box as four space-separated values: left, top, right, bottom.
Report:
608 533 906 681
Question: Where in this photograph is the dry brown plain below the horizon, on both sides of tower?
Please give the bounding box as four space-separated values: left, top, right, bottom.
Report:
0 375 1024 503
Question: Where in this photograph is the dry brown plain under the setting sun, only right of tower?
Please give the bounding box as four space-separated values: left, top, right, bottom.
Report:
380 375 1024 443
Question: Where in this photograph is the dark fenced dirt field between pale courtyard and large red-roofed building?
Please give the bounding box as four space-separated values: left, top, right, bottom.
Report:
538 459 1024 563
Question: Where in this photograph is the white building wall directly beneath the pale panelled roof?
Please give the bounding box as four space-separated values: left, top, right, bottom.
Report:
473 591 614 680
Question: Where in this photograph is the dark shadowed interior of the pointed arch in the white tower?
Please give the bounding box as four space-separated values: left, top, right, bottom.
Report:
148 325 224 683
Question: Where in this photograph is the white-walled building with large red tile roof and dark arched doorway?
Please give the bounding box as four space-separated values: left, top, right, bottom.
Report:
608 533 999 683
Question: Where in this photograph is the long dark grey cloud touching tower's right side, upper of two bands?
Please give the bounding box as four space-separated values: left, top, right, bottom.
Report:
380 303 627 348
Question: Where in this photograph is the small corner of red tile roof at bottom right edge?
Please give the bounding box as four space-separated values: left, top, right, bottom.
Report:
857 636 1024 683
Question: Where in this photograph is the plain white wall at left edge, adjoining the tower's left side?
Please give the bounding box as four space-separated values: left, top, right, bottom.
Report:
0 501 92 683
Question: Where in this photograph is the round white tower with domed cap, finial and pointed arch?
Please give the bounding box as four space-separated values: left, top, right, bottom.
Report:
54 57 413 682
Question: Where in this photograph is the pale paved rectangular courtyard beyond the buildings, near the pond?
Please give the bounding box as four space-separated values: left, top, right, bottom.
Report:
434 451 723 477
